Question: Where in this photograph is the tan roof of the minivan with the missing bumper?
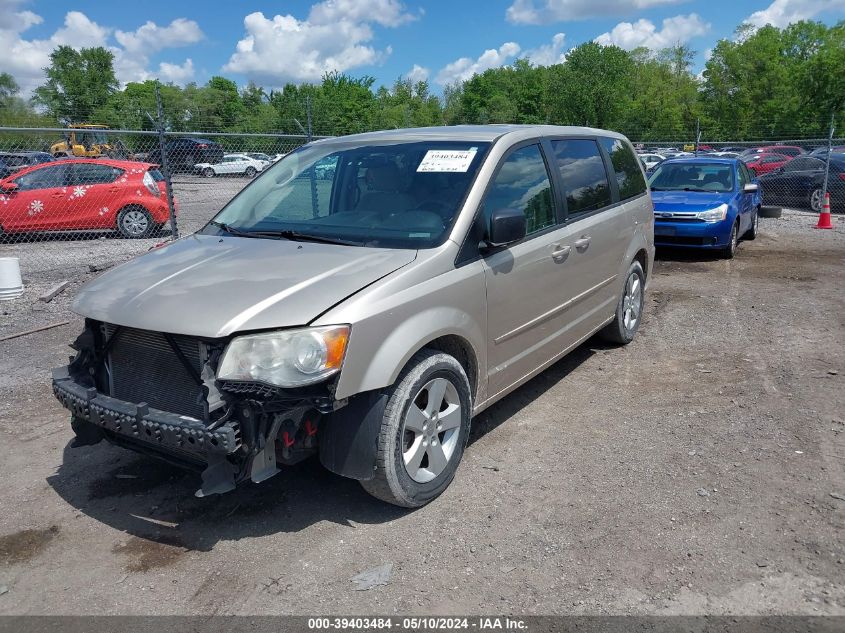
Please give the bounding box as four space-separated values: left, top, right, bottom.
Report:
314 123 625 143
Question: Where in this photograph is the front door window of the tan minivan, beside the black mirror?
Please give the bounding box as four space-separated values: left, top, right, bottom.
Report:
484 145 556 234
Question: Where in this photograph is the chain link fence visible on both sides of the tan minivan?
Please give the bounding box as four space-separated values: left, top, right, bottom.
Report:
0 118 845 306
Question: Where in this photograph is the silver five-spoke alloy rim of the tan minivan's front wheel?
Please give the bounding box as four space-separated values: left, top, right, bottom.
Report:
402 378 462 483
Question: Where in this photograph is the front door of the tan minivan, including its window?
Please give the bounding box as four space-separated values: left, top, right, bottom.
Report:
484 145 596 397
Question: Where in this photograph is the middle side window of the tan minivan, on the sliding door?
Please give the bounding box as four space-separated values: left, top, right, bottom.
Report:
552 139 610 216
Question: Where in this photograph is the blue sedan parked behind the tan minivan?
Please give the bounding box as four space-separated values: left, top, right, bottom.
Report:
649 156 762 258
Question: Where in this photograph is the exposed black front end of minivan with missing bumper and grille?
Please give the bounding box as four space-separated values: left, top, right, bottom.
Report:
53 319 345 496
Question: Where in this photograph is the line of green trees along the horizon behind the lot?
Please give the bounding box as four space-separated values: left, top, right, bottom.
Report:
0 21 845 141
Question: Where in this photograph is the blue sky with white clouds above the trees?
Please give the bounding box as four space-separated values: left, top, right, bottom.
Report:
0 0 845 96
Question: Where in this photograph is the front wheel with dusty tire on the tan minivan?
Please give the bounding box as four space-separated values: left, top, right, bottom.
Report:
361 349 472 508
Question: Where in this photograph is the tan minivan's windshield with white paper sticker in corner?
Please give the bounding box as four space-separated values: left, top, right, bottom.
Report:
202 140 489 249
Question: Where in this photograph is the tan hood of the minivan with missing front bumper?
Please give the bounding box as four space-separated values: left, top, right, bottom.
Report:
73 235 417 338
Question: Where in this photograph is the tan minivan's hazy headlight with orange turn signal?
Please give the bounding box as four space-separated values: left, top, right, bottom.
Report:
217 325 349 387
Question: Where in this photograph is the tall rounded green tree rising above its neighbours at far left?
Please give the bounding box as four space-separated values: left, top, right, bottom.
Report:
33 46 118 123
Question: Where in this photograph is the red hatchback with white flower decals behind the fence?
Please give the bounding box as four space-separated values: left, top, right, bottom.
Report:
0 158 176 238
